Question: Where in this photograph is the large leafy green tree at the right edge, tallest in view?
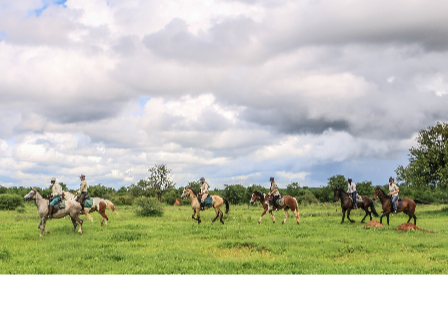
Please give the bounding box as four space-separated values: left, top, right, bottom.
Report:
396 122 448 188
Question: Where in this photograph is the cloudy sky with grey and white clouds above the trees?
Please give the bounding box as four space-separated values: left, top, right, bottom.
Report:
0 0 448 188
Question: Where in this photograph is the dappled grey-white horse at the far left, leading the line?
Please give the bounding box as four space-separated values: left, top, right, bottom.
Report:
23 189 83 237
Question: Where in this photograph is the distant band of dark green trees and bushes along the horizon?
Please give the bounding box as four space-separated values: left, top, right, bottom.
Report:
0 175 448 206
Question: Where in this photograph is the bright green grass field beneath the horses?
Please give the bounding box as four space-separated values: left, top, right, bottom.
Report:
0 204 448 274
